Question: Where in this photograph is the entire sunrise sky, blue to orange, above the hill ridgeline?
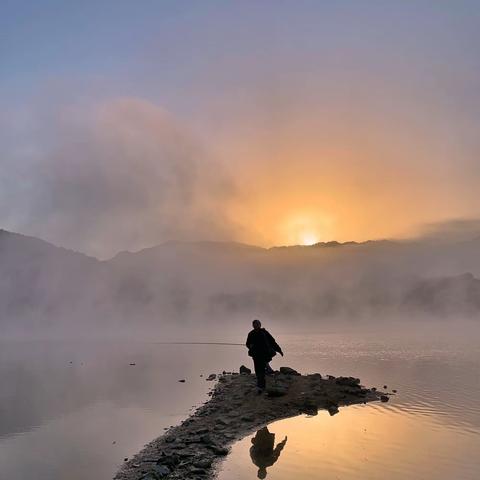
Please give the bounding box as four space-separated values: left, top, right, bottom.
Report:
0 0 480 258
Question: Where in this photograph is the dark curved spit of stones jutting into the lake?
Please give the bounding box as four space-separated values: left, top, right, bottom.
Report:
114 367 382 480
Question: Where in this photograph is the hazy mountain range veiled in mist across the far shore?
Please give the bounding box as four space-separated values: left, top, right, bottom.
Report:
0 230 480 336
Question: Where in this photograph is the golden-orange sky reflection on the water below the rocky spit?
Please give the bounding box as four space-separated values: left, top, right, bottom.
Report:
218 405 480 480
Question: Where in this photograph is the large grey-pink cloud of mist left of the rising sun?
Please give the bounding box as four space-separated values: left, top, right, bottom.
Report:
0 98 239 257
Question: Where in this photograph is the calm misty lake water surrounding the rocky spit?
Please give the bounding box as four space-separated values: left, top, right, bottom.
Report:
0 330 480 480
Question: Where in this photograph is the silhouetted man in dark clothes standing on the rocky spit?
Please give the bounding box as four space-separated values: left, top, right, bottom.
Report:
246 320 283 394
